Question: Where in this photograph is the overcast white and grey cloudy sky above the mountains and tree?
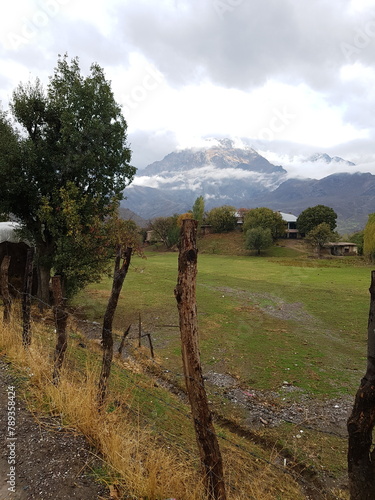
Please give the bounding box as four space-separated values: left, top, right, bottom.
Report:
0 0 375 176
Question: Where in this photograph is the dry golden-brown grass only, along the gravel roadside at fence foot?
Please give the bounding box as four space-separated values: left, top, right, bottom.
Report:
0 308 310 500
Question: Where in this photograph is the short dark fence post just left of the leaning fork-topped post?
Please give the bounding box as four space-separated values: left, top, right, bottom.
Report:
52 276 68 385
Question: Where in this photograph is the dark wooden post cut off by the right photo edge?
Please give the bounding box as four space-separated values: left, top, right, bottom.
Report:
348 271 375 500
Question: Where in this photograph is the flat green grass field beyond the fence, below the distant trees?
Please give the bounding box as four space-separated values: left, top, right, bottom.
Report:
75 235 371 396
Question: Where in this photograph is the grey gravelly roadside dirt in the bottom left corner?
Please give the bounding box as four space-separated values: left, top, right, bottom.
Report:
0 360 110 500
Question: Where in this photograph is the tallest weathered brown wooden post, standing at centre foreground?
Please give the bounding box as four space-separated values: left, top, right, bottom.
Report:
175 219 226 500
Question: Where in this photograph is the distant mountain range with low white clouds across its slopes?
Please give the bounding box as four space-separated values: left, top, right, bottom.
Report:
122 139 375 232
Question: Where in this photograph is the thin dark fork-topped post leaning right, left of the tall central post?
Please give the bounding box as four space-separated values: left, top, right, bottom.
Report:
98 247 132 408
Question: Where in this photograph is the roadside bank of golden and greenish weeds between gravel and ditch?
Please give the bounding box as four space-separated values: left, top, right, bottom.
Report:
0 306 314 500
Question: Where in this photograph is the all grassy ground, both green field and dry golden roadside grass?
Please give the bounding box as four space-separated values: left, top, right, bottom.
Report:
0 233 371 500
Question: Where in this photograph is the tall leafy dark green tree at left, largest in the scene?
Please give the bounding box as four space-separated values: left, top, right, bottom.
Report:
0 55 135 301
